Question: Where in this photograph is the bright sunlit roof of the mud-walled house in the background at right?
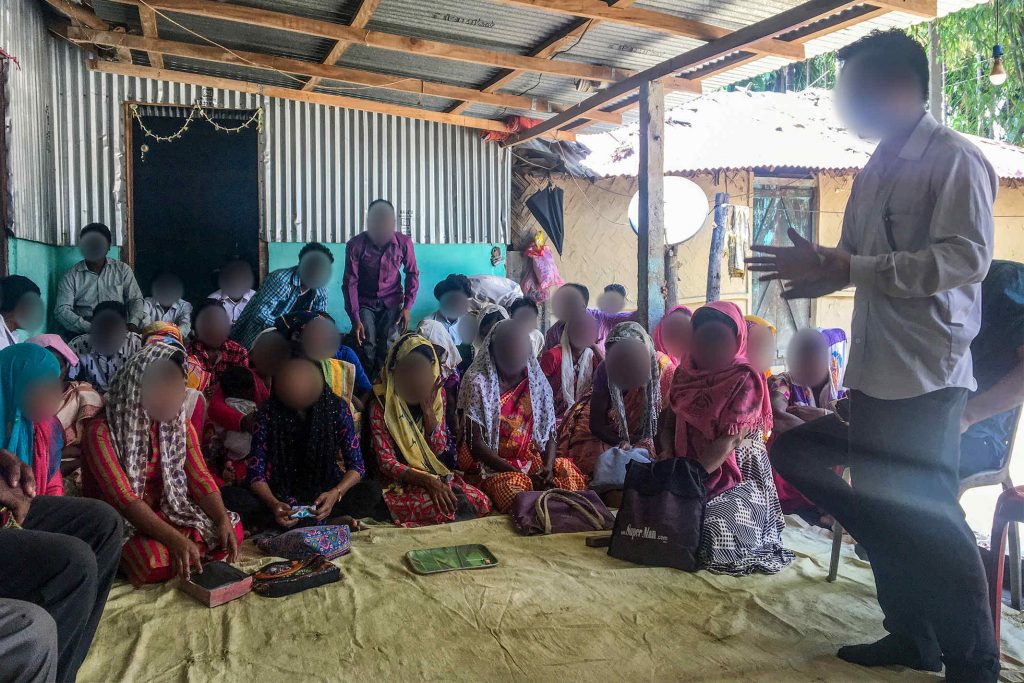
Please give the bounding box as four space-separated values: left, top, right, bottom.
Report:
578 89 1024 178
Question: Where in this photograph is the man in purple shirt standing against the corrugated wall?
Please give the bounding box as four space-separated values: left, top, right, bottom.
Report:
342 200 420 380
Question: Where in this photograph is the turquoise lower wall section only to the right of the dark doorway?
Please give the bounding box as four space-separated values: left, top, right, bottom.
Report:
267 242 505 332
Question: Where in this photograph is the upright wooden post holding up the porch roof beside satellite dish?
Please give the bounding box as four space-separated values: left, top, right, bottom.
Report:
637 81 665 330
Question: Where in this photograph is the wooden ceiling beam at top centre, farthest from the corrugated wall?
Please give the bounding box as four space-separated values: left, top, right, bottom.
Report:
491 0 802 61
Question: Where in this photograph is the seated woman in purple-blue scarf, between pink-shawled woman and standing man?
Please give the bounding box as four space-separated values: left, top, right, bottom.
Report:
768 328 847 516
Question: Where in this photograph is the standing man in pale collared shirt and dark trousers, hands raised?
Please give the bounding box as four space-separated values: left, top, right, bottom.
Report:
750 31 999 681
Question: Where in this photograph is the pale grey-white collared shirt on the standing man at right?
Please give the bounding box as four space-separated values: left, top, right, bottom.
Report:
840 114 998 400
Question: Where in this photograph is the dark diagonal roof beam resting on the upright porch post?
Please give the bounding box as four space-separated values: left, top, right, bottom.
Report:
503 0 857 145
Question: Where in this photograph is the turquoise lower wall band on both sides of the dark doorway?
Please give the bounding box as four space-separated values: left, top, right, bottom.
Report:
8 239 505 331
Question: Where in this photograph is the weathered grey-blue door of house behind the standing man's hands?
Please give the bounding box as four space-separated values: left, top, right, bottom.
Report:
751 177 815 365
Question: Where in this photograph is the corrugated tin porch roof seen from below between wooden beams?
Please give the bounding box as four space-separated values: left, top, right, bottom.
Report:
68 0 981 131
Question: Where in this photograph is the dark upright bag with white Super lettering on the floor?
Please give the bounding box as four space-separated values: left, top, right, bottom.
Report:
608 458 708 571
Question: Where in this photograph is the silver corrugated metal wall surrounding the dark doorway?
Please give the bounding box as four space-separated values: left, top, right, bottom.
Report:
7 32 511 244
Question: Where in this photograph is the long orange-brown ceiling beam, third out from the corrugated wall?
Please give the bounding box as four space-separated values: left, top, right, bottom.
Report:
110 0 633 81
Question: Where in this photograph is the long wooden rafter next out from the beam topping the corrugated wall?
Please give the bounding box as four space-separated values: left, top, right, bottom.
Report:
67 28 622 123
